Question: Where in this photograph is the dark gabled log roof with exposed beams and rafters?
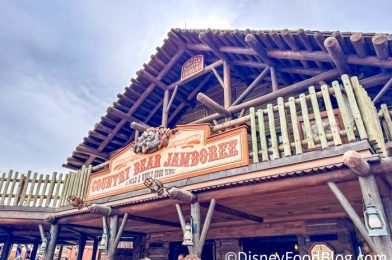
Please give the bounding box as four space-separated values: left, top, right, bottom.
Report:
63 29 392 169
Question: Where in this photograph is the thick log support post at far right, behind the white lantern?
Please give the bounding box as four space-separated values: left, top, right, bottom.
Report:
343 151 392 259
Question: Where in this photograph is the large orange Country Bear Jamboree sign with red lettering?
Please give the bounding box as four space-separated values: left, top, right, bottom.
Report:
86 124 249 200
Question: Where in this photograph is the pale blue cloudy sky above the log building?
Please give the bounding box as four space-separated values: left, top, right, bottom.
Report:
0 0 392 173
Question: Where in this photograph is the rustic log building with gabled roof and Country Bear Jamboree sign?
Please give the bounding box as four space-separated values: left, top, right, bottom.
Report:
0 29 392 260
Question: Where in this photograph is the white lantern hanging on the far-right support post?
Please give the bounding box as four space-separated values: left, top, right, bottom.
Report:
364 204 388 237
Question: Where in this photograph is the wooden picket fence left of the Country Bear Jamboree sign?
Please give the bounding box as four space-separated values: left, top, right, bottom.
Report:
0 167 91 208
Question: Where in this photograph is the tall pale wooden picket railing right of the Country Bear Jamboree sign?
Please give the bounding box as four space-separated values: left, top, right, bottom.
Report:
249 75 386 162
